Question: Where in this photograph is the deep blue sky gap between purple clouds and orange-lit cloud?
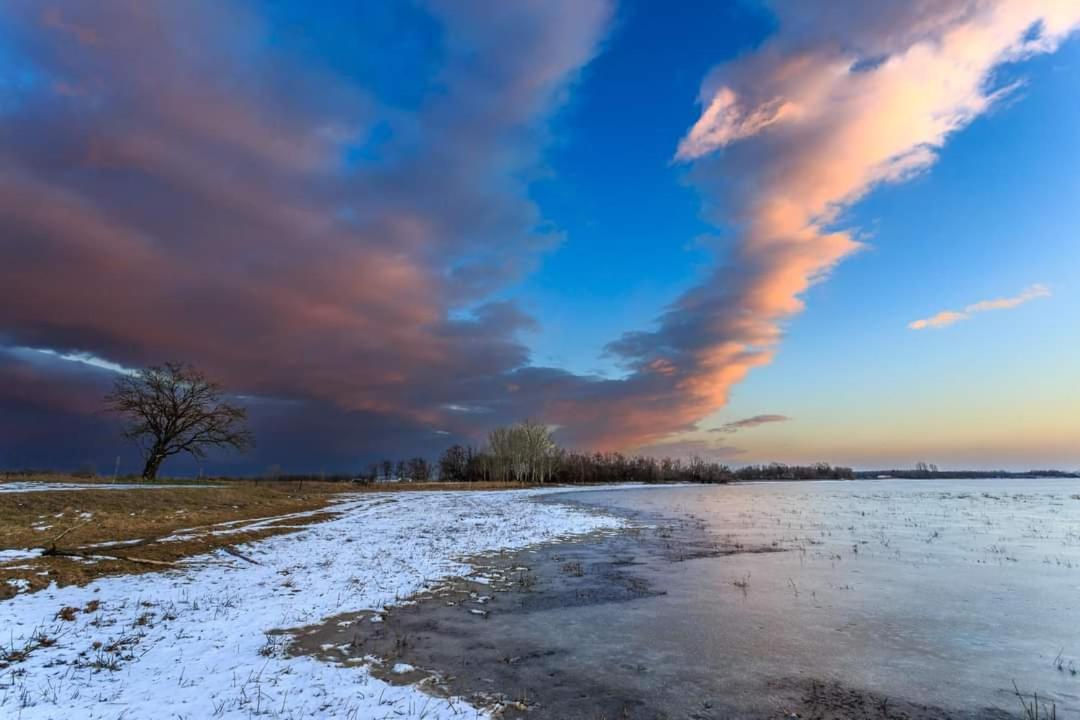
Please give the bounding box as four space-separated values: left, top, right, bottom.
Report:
517 0 774 375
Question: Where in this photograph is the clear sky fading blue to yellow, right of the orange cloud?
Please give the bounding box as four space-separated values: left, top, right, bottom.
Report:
708 33 1080 467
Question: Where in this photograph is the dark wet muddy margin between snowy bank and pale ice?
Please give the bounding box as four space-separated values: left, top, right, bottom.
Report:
281 496 778 720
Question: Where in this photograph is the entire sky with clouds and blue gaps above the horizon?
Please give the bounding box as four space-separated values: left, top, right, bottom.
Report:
0 0 1080 473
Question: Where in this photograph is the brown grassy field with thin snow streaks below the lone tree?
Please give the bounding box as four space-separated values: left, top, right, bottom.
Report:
0 478 341 597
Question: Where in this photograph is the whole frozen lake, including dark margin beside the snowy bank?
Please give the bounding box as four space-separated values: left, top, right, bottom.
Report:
292 479 1080 720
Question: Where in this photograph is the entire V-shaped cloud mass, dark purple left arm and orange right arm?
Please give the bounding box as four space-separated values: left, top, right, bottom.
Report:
0 0 1080 465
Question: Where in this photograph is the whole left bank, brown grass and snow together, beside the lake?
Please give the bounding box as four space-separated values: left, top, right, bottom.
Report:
0 474 618 720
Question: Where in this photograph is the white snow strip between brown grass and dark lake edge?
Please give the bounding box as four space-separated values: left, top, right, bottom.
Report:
0 491 620 720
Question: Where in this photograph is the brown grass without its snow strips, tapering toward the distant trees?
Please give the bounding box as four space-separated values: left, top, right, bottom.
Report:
0 474 548 599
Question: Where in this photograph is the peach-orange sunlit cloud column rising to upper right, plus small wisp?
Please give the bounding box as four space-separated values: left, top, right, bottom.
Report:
574 0 1080 445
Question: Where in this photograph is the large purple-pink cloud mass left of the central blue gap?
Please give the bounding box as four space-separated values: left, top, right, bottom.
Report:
0 0 611 468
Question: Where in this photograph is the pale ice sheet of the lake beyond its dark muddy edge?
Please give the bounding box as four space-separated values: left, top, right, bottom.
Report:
548 479 1080 717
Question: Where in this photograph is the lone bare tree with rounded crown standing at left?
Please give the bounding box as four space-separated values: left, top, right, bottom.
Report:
105 363 255 479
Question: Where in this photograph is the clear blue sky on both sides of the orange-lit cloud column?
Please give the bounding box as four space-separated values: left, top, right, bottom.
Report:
507 3 1080 467
